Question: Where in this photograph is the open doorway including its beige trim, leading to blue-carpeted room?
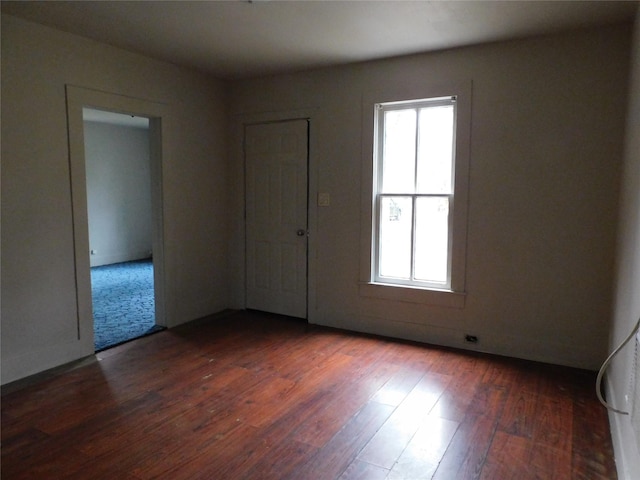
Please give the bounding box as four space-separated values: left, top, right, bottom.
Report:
66 85 168 355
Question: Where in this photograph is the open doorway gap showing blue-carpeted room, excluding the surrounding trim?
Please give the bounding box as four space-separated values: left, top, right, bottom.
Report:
83 108 164 352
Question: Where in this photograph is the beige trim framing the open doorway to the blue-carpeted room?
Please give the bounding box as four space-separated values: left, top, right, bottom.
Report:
66 85 168 355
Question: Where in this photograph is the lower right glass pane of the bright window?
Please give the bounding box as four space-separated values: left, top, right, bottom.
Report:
414 197 449 284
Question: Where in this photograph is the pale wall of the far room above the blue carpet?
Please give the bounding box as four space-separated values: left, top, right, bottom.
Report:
84 121 152 267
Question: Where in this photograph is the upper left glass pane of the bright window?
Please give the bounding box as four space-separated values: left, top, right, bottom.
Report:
382 110 416 193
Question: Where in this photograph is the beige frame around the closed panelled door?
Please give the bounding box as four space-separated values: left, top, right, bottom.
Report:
230 107 320 322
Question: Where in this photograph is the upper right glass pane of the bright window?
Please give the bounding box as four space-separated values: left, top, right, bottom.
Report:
417 105 454 193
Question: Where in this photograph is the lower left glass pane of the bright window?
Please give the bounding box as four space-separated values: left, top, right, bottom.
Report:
378 197 412 279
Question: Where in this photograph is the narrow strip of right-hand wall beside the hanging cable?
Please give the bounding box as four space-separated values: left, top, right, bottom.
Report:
607 11 640 480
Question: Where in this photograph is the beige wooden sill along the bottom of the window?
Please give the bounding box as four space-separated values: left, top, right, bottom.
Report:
360 282 466 308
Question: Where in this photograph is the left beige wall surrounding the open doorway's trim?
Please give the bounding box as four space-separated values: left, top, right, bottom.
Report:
1 15 230 384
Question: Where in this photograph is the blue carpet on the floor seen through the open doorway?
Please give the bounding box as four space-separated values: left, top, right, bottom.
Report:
91 260 164 352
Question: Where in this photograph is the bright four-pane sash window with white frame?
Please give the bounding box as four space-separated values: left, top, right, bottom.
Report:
372 96 457 290
